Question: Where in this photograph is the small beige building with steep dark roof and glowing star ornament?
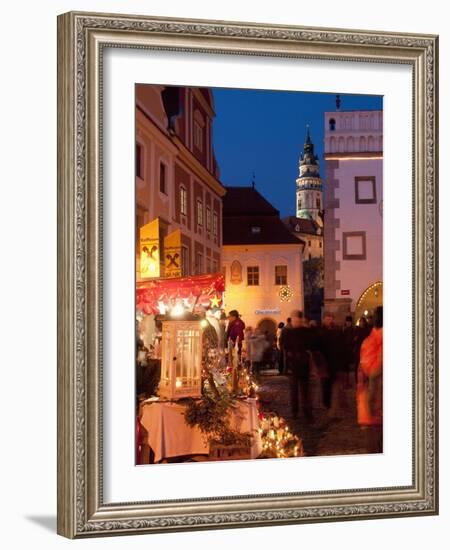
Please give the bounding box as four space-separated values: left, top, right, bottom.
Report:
222 187 304 335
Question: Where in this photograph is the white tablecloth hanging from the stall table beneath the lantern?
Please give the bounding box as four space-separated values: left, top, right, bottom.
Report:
140 398 262 462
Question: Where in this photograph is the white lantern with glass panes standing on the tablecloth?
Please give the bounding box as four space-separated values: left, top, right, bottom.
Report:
159 320 202 399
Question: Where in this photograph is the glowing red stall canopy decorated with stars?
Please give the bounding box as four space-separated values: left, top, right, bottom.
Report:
136 273 225 315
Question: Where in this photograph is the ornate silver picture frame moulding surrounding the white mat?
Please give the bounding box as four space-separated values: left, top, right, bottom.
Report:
57 12 438 538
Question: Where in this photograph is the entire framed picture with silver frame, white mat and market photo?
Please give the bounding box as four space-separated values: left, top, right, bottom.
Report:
58 12 438 538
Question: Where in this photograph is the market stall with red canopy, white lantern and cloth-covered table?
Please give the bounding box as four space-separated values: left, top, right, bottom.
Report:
136 274 301 464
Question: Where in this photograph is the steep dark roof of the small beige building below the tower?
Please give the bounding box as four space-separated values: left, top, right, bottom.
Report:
222 187 300 245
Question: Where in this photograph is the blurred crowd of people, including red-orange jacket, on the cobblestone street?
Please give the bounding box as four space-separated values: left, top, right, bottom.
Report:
224 306 383 426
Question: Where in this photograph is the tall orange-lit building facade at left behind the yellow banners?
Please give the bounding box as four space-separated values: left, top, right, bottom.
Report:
136 85 225 281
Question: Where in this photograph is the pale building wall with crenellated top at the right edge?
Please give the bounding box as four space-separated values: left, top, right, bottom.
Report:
324 110 383 311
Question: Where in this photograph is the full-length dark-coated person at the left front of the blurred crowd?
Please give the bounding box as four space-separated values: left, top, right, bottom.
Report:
282 310 312 420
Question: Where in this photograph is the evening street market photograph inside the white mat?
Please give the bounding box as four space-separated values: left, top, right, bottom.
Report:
135 84 383 465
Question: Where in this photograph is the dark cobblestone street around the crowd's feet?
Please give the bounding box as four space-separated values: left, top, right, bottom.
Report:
255 374 382 456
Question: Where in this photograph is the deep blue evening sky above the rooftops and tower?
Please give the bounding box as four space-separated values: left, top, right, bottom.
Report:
213 88 382 217
